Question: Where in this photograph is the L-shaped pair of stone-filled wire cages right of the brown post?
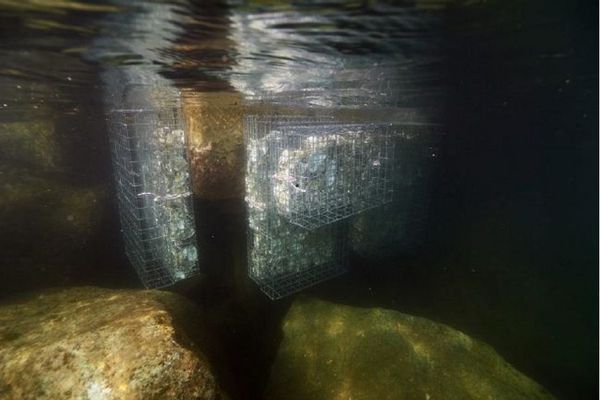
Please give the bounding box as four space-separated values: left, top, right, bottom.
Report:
244 117 394 298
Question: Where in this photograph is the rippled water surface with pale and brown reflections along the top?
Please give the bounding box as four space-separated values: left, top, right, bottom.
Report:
0 1 444 114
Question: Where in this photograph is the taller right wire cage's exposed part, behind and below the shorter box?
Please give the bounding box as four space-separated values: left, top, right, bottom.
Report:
245 117 347 299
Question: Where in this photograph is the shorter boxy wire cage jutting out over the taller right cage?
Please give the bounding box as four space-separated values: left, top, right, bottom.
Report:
245 117 395 229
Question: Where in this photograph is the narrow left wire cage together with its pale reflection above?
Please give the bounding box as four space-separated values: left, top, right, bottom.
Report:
86 2 198 288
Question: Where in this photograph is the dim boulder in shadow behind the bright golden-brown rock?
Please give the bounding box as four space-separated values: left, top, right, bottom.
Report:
0 168 108 296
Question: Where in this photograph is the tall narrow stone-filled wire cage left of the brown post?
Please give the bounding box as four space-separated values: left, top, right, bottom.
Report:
108 107 198 288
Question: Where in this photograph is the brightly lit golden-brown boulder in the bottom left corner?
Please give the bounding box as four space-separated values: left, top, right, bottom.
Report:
0 287 221 400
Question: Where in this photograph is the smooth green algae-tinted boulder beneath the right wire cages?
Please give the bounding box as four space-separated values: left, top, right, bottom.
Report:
266 298 553 400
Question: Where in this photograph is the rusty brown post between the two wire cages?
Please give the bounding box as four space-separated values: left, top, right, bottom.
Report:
182 92 245 200
